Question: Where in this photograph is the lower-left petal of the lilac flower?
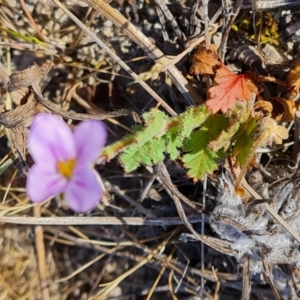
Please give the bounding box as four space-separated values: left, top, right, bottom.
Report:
26 164 68 202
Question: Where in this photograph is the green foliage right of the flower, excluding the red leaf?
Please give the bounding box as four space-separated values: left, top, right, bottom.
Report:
101 101 270 181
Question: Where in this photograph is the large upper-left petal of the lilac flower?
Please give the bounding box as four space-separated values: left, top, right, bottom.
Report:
28 113 76 164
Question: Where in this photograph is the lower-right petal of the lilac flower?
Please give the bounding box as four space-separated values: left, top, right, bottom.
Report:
65 167 103 213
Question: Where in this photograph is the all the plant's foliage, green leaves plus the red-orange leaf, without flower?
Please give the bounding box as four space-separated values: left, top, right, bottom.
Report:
102 58 288 184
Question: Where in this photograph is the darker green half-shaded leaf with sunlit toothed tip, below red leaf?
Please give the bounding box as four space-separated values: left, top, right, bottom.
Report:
183 114 228 181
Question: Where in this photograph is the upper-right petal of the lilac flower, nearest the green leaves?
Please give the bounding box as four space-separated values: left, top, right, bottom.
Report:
73 120 107 165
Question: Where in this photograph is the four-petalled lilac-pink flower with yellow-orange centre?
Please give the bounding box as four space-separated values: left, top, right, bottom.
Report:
26 113 107 212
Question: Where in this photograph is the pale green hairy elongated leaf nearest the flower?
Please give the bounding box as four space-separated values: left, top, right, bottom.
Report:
105 106 210 172
